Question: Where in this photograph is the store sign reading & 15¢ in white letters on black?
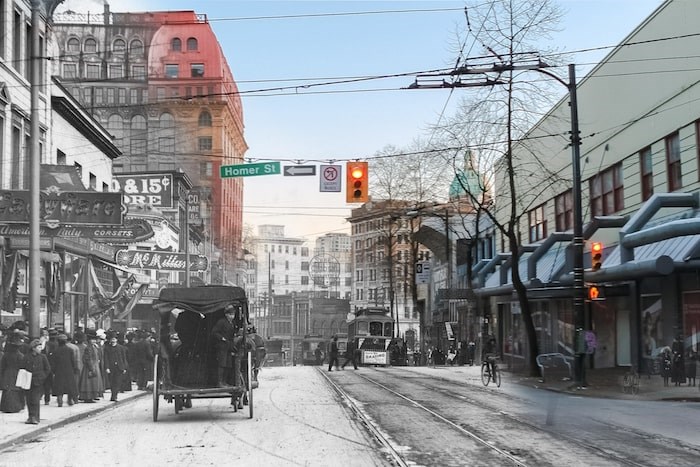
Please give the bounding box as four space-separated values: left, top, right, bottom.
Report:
112 174 173 208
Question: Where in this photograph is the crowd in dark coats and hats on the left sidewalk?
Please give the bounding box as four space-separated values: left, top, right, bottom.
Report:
0 321 157 425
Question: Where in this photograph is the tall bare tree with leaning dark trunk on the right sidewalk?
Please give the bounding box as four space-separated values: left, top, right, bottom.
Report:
436 0 566 375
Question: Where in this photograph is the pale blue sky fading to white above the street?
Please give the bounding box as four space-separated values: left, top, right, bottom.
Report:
57 0 664 239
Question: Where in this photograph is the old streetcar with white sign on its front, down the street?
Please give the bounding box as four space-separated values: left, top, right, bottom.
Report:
348 307 394 366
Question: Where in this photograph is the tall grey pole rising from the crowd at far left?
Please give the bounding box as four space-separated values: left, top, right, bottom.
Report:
29 0 63 338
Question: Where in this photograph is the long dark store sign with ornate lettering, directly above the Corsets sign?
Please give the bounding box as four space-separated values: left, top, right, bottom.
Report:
0 190 123 228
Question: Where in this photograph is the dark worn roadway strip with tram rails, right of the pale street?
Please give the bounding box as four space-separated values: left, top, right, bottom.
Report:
319 367 700 466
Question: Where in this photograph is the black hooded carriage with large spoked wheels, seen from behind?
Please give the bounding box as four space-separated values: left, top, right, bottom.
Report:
153 286 264 422
